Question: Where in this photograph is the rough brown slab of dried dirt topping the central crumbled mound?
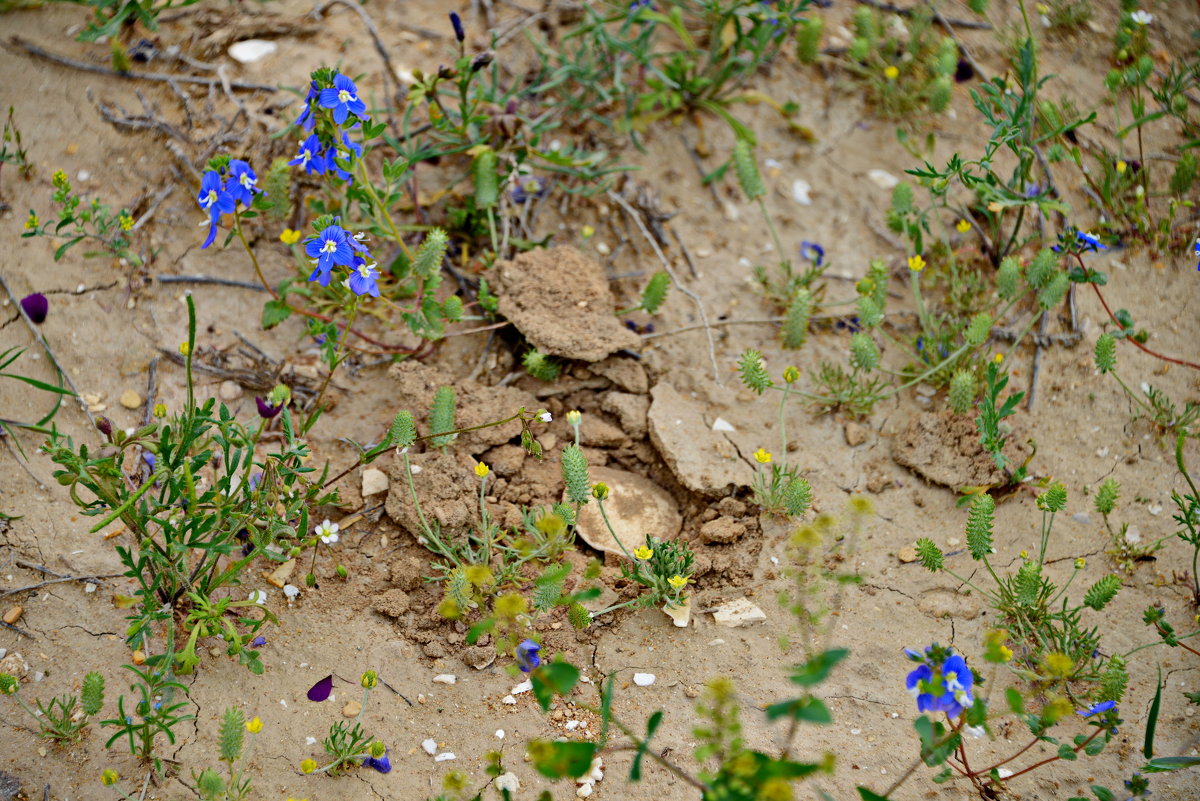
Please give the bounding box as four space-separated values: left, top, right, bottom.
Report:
496 247 642 362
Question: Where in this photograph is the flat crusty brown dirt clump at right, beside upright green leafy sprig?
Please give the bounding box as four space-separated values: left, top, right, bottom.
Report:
892 409 1030 489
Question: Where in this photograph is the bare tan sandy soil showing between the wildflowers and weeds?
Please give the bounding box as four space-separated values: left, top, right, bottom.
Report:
0 0 1200 801
